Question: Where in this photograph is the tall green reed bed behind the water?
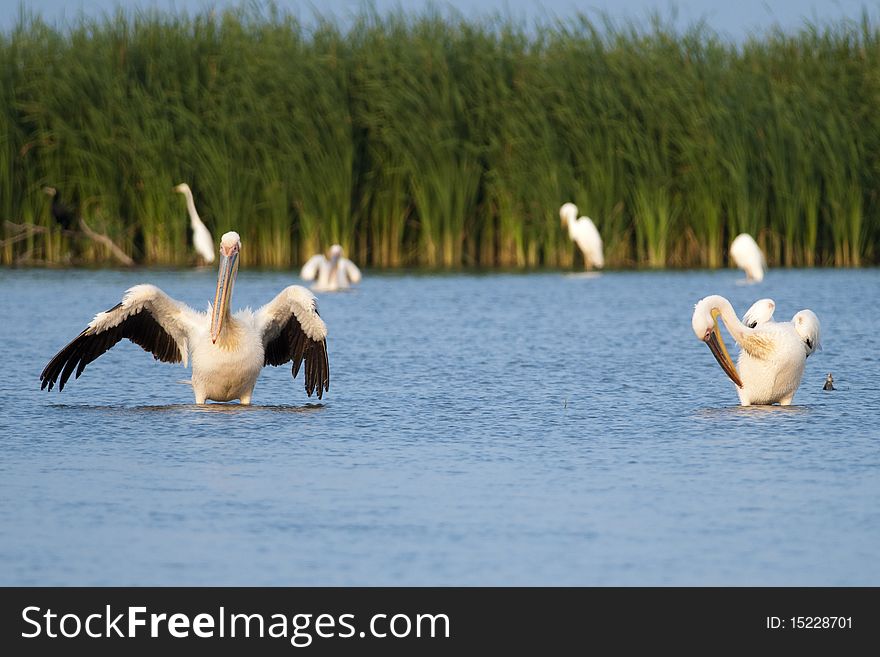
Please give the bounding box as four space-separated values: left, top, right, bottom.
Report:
0 4 880 268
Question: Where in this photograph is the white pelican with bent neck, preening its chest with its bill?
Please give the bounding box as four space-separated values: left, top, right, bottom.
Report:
691 295 819 406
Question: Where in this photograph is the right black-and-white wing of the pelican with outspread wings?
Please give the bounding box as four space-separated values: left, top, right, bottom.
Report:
257 284 330 399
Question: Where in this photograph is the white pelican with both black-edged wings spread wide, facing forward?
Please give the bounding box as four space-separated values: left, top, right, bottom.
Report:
40 232 330 404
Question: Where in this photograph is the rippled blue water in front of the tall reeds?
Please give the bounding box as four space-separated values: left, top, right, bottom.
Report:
0 269 880 586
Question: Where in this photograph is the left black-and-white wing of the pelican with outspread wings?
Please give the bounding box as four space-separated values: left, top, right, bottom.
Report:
40 285 198 390
